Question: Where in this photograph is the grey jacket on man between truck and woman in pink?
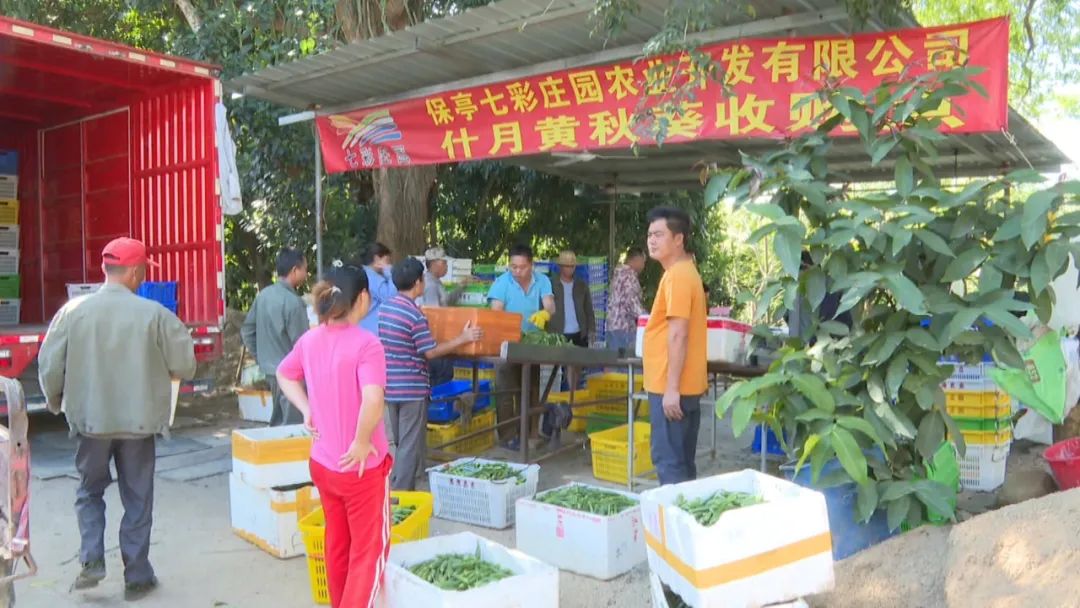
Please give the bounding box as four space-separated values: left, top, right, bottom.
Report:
240 280 309 378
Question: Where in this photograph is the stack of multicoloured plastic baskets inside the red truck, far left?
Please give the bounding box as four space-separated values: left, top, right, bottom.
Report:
0 150 23 325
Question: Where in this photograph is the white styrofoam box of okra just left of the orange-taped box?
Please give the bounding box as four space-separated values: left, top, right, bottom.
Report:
516 484 645 580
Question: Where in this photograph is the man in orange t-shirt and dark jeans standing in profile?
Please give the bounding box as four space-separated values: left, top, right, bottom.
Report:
643 207 708 485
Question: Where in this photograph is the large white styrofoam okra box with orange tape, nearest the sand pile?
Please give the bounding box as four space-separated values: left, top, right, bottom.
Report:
642 469 834 608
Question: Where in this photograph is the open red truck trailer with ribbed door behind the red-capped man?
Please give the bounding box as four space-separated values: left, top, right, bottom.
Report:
0 16 225 410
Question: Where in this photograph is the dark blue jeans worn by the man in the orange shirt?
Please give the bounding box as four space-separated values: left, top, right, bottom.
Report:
649 393 701 486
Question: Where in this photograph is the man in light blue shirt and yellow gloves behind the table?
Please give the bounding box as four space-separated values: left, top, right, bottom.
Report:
487 245 555 451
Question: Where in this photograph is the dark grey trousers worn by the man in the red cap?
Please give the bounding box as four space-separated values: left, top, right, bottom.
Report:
75 436 156 583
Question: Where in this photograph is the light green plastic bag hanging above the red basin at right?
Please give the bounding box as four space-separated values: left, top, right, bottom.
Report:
990 332 1066 424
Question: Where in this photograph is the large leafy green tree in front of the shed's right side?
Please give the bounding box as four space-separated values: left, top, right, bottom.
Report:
710 68 1080 528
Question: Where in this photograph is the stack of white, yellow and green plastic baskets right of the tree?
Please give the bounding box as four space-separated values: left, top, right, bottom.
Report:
942 361 1012 491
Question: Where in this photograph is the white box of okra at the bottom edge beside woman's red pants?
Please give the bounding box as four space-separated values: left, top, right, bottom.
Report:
383 532 558 608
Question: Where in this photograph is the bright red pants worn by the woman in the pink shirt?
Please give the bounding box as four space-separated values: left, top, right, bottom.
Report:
311 456 393 608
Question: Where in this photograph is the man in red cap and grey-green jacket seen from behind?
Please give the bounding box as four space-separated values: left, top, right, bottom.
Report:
38 239 195 600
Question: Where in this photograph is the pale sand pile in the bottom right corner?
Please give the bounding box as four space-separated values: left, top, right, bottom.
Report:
811 489 1080 608
